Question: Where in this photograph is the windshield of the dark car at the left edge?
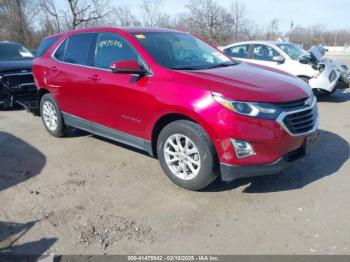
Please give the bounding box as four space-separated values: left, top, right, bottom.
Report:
0 43 34 61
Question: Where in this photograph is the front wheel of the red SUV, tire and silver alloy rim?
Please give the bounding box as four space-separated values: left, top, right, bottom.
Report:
157 120 219 191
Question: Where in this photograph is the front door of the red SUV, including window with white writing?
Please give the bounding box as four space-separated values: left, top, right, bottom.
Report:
87 32 150 137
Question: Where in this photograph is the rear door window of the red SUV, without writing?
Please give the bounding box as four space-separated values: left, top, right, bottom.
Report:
64 33 97 66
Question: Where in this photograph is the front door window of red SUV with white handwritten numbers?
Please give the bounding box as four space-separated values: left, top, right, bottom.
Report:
95 33 138 69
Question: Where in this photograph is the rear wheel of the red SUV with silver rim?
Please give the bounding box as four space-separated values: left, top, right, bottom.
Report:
40 94 67 137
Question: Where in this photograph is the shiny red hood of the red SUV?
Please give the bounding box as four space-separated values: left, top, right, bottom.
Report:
173 62 312 102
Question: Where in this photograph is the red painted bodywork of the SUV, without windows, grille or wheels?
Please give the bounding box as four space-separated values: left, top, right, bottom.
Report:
33 28 310 165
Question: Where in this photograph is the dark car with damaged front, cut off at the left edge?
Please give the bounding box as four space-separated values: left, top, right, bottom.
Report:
0 41 36 108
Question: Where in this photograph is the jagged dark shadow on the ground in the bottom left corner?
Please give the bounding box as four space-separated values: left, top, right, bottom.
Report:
0 221 57 256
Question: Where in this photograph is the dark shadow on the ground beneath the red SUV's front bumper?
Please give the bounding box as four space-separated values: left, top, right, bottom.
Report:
203 130 350 193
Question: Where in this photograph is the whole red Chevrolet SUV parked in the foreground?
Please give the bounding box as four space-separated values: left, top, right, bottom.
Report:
33 28 318 190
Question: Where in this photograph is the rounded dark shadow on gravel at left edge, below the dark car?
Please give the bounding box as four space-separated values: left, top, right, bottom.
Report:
0 132 46 191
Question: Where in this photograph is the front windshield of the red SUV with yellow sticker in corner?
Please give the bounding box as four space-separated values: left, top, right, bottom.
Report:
134 32 236 70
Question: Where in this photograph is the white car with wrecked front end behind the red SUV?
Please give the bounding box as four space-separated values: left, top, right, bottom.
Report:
220 41 340 94
